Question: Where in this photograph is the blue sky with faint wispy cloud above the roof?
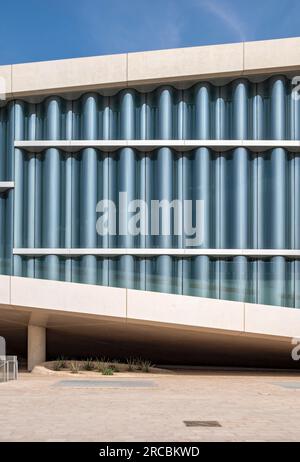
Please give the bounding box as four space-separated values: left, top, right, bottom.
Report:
0 0 300 64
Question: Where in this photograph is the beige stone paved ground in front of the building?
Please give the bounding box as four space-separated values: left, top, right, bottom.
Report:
0 372 300 442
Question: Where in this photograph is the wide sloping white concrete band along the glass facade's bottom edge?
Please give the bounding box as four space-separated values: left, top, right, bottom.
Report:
0 276 300 338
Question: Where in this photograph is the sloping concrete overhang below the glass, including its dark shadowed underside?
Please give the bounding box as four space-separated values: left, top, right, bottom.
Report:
0 276 300 368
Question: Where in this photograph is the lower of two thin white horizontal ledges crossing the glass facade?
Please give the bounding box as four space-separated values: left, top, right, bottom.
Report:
13 248 300 258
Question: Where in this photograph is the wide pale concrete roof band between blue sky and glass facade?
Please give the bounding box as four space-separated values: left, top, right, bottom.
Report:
0 37 300 98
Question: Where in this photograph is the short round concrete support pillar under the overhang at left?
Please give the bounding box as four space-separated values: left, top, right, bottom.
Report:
27 324 46 371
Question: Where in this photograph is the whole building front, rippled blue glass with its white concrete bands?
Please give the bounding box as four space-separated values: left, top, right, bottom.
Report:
0 39 300 365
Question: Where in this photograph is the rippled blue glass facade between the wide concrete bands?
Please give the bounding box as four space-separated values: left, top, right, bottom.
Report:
0 76 300 308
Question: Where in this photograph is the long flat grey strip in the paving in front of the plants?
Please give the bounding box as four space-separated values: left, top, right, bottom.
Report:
54 380 156 388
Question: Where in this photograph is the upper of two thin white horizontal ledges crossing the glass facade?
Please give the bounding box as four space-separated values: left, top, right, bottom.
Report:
15 140 300 152
